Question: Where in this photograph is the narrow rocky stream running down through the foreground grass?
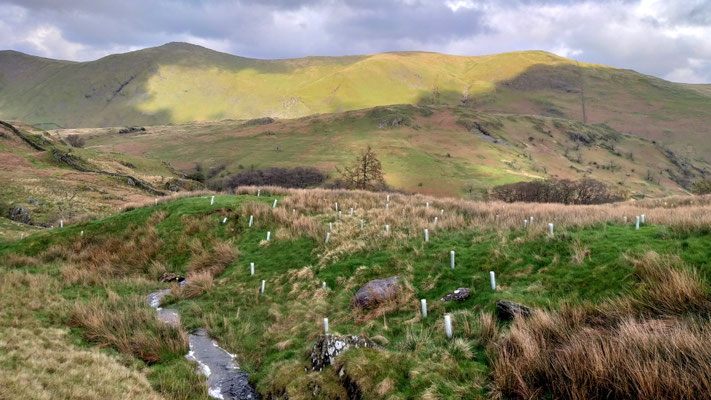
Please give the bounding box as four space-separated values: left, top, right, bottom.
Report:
146 289 261 400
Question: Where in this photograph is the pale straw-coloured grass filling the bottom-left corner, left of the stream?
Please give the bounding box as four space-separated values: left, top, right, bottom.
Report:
0 269 162 400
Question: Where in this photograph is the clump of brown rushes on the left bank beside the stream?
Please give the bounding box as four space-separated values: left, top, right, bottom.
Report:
68 295 188 364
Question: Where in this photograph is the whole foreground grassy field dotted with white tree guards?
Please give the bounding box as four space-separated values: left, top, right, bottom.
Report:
0 188 711 399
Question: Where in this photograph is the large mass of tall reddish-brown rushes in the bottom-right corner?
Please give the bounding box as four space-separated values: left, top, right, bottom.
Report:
492 253 711 399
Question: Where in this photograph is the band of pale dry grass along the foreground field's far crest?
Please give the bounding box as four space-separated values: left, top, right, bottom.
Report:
235 187 711 267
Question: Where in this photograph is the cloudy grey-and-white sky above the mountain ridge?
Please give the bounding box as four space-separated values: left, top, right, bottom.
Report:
0 0 711 83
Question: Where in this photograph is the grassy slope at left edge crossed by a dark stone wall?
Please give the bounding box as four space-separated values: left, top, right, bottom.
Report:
0 121 195 241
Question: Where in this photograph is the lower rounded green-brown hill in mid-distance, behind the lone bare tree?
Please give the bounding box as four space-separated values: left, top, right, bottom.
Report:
58 105 708 198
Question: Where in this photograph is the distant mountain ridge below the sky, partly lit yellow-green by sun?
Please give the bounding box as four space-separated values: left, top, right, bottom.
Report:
0 43 711 157
